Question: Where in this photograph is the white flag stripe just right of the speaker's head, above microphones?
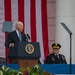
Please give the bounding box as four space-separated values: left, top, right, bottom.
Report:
24 0 31 42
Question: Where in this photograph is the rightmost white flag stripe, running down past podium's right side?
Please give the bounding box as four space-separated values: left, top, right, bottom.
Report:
36 0 44 63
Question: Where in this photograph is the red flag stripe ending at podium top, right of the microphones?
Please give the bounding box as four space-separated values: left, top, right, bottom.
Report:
30 0 36 42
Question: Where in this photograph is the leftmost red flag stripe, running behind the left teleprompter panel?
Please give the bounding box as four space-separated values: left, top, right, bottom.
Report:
4 0 11 62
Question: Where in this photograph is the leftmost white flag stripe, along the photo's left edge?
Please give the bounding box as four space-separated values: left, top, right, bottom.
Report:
0 0 5 58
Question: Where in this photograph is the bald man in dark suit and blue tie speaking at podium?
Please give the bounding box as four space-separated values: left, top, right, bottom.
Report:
5 21 28 47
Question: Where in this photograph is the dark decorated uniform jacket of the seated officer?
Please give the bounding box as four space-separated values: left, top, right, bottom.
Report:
45 53 67 64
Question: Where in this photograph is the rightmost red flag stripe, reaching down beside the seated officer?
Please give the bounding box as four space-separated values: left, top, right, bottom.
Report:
41 0 49 57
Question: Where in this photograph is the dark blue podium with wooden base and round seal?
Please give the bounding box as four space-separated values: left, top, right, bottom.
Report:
8 42 41 68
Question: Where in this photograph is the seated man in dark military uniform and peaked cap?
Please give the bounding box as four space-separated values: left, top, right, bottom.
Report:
45 43 67 64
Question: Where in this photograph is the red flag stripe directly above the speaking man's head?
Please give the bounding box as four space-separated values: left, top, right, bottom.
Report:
18 0 24 32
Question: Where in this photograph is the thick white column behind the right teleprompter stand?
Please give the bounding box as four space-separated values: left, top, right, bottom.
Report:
55 0 75 64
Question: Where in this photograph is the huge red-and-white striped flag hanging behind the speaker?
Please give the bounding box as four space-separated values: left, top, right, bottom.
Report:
0 0 49 63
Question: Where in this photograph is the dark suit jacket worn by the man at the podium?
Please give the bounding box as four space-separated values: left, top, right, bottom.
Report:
5 30 27 47
